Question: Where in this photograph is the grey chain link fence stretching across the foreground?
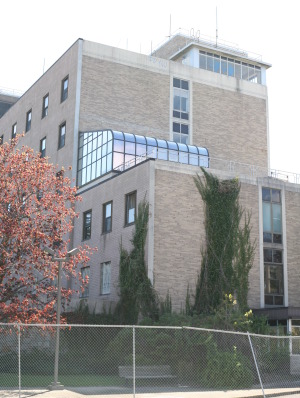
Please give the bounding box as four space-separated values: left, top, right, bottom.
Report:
0 324 300 397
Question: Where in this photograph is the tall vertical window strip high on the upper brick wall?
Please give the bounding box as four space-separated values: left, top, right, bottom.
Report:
173 78 190 144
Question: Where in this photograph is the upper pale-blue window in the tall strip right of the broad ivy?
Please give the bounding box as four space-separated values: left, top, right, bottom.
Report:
262 188 282 244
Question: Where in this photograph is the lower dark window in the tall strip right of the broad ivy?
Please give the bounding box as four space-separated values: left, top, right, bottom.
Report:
264 248 283 305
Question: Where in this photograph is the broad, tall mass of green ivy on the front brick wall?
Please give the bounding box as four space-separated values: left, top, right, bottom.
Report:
194 168 255 313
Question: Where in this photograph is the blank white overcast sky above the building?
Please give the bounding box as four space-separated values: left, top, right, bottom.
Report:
0 0 300 174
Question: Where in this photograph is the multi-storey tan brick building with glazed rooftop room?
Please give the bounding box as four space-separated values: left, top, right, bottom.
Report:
0 35 300 327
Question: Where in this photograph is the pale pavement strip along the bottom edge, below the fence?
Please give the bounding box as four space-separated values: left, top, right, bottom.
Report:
0 387 300 398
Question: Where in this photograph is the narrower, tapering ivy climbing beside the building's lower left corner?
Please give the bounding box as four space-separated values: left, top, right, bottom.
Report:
116 199 159 324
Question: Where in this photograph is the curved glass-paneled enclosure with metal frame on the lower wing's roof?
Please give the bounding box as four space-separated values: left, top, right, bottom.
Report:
77 130 209 186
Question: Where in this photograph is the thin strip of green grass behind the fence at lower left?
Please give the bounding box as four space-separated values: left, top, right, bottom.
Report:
0 373 125 388
